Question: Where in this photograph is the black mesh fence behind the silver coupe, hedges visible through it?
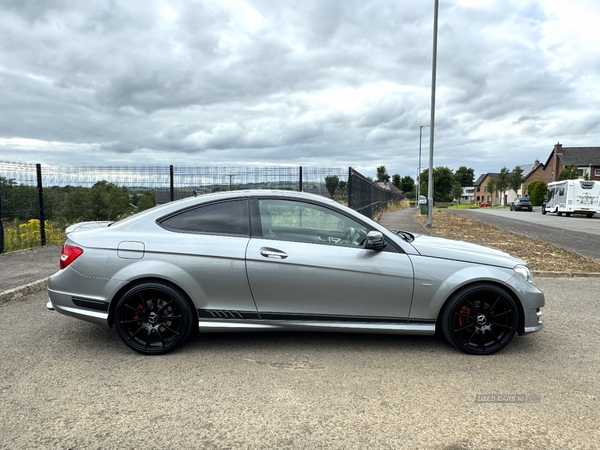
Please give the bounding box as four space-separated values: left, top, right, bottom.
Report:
0 161 397 253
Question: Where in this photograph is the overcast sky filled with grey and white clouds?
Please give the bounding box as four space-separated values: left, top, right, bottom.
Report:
0 0 600 178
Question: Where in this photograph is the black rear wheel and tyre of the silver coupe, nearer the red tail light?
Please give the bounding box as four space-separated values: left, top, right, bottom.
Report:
115 281 193 355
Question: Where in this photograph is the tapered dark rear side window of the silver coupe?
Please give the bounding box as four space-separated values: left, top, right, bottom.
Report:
160 200 250 236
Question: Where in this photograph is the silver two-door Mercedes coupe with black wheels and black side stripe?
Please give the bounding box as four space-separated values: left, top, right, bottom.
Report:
47 190 544 355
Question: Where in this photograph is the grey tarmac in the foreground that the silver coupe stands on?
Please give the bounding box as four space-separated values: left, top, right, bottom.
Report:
0 278 600 450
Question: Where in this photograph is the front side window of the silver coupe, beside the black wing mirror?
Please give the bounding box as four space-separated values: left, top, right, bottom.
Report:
259 199 367 246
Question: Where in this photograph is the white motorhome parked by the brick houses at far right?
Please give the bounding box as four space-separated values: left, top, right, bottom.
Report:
542 180 600 217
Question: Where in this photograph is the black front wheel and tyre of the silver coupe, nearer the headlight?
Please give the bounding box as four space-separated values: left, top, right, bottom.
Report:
440 283 519 355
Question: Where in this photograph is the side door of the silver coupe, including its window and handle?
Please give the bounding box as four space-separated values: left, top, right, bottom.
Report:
246 199 413 321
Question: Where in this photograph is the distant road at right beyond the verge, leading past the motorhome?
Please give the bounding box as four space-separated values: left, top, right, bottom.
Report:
448 207 600 259
